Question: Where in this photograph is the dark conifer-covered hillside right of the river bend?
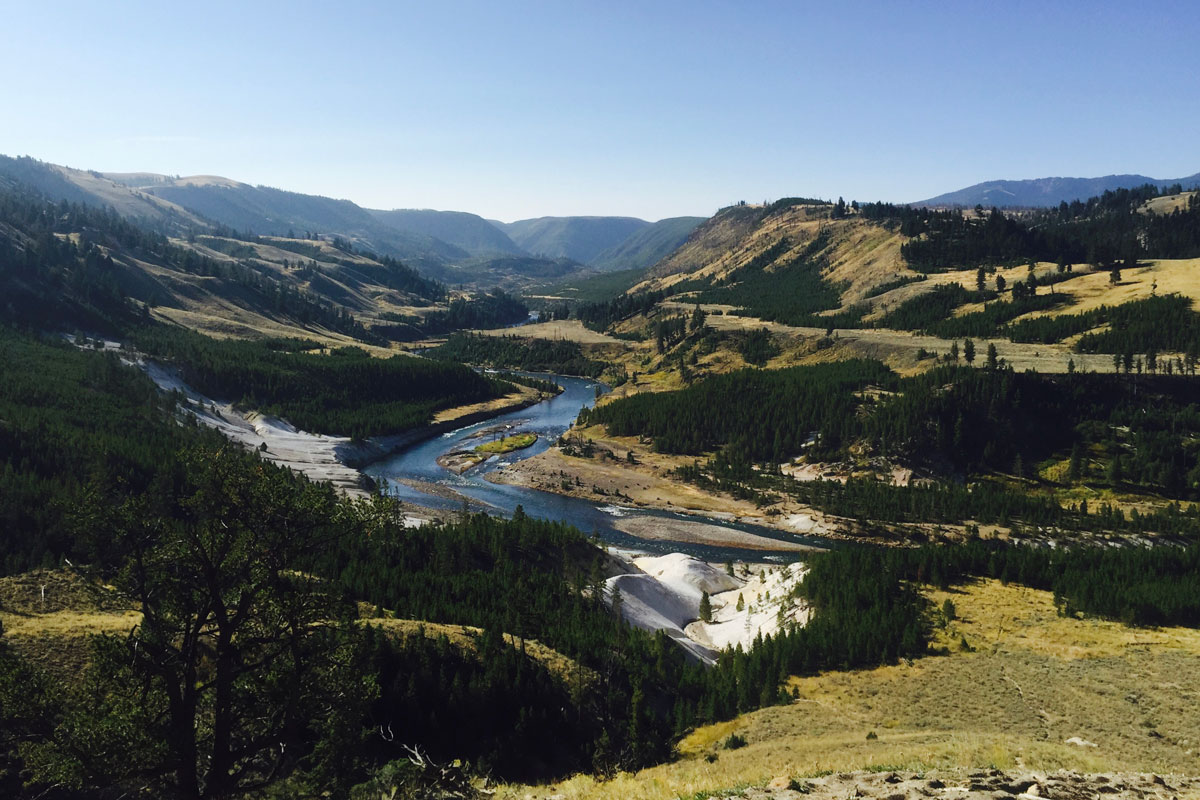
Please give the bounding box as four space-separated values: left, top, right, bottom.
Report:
592 361 1200 500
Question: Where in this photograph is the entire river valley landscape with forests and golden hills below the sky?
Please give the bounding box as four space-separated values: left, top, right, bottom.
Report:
0 154 1200 798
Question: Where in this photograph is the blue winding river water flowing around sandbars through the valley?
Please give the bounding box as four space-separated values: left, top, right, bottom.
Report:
364 374 832 561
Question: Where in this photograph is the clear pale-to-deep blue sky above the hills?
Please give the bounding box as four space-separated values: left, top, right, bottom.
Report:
0 0 1200 219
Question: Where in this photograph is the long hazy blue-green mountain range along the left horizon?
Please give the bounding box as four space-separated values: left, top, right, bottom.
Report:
0 156 671 289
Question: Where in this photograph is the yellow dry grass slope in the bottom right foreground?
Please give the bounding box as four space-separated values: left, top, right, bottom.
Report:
499 581 1200 800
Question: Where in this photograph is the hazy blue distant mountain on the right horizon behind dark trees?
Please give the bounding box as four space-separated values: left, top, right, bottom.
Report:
910 173 1200 207
